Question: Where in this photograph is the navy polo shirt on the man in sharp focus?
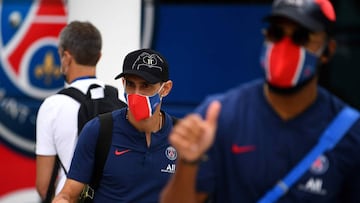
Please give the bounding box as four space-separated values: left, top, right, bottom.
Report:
68 108 177 203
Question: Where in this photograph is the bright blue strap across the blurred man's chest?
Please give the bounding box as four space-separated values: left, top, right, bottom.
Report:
258 107 360 203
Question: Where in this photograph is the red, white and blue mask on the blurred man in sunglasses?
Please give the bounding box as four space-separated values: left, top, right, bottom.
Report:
260 37 319 89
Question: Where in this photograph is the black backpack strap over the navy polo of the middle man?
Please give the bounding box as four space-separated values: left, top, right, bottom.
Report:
90 112 113 190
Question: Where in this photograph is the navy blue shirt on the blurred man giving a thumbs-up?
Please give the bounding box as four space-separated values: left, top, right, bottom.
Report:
197 80 360 203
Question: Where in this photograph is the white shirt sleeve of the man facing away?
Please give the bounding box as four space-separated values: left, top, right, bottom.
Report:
36 94 80 160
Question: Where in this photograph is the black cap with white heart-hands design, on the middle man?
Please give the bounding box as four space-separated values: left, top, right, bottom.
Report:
115 49 169 84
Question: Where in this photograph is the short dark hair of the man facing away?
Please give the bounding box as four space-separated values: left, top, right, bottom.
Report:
59 21 102 66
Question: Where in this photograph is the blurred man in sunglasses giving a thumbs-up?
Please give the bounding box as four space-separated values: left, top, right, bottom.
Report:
160 0 360 203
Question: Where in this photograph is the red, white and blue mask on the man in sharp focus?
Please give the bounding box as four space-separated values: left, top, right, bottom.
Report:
124 83 163 121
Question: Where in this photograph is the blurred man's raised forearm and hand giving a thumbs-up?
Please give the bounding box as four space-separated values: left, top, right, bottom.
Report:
160 101 221 203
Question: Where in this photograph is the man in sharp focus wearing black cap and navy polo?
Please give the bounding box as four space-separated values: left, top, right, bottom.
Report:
53 49 177 203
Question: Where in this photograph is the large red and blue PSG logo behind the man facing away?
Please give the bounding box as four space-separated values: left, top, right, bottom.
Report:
0 0 67 203
